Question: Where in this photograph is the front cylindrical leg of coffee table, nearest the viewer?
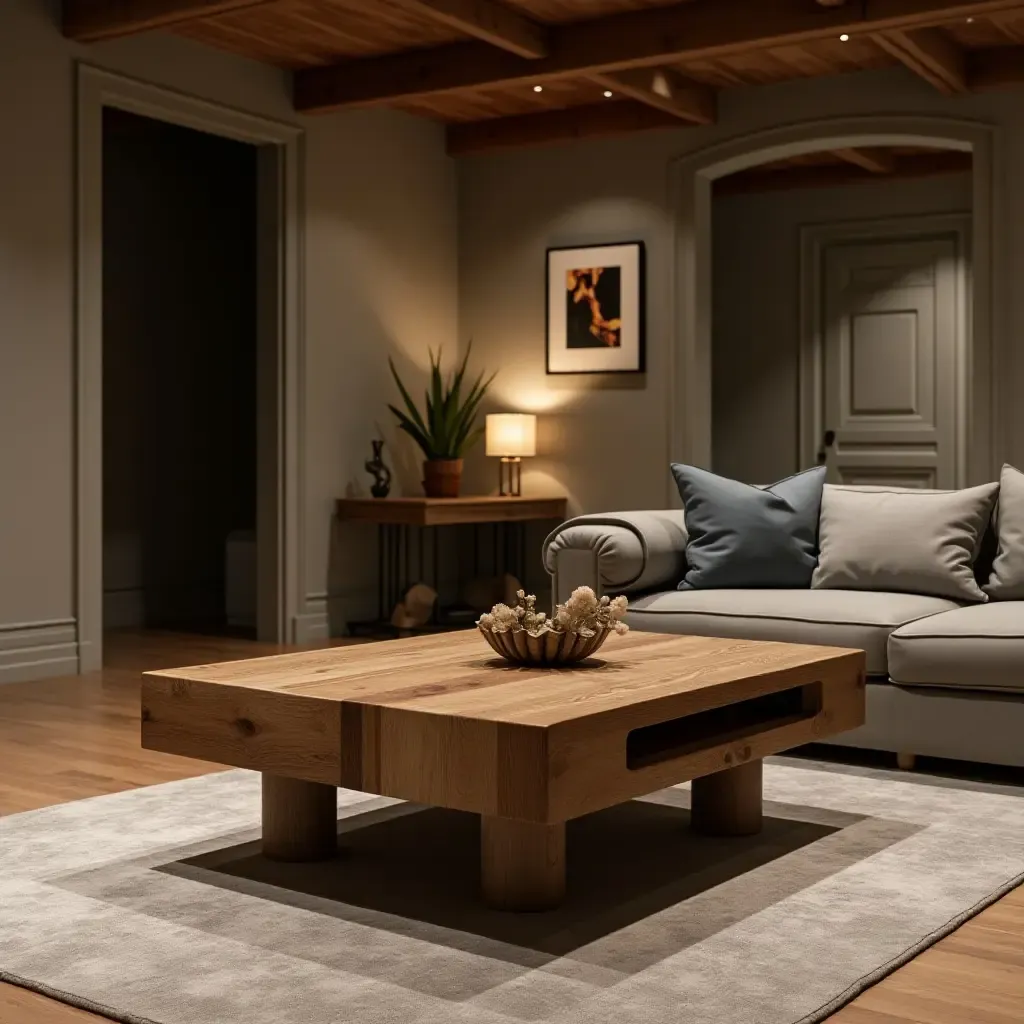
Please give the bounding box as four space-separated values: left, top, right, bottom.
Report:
480 815 565 910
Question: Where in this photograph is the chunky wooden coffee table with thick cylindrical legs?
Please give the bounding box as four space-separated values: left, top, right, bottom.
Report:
142 630 864 910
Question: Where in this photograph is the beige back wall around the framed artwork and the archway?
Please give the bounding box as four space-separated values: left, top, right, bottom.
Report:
459 70 1024 512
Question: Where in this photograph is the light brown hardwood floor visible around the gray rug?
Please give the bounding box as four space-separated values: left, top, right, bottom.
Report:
0 633 1024 1024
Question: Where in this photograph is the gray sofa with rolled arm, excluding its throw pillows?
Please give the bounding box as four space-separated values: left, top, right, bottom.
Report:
544 471 1024 767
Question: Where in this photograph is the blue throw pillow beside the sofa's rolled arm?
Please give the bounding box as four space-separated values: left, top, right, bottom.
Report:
672 463 825 590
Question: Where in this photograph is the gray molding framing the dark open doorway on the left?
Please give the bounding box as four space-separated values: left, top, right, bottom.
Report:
74 62 305 672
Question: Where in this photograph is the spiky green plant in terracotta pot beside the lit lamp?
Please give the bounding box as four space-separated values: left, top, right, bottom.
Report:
388 345 495 498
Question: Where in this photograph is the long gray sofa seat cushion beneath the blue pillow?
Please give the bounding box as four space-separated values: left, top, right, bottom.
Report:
627 590 958 676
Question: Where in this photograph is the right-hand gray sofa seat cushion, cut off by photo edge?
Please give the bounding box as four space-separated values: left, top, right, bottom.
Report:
889 601 1024 696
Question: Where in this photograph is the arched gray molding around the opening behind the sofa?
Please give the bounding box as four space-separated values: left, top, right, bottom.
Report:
666 115 1011 507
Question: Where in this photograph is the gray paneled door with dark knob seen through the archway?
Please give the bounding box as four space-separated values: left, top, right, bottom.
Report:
816 232 966 487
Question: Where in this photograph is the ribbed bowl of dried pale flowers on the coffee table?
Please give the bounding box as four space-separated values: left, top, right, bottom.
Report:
476 587 629 665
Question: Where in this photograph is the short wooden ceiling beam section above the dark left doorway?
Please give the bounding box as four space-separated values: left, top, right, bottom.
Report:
61 0 272 43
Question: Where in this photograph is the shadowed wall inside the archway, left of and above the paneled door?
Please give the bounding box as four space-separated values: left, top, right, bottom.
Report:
712 174 972 482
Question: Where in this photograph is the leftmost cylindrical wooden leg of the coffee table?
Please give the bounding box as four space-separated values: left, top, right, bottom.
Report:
263 772 338 861
